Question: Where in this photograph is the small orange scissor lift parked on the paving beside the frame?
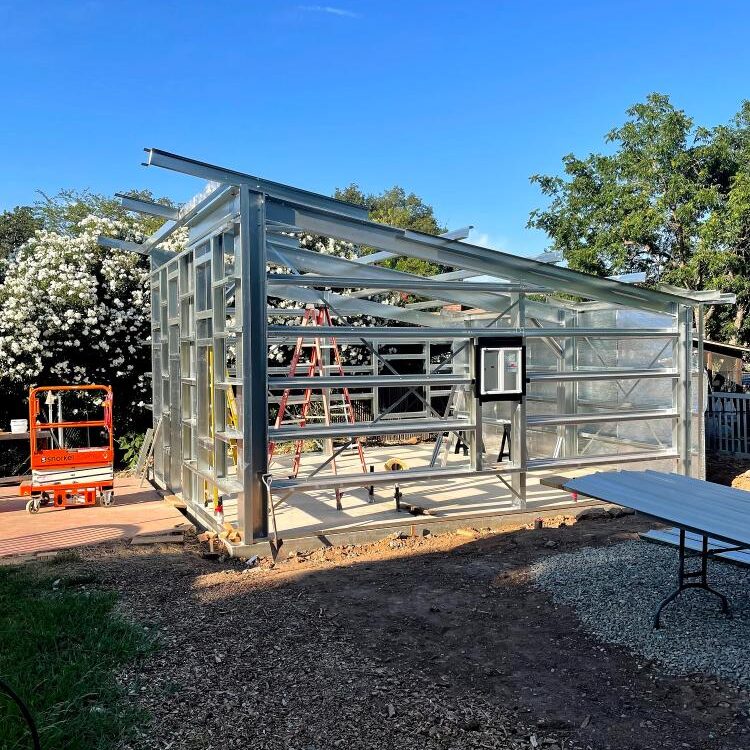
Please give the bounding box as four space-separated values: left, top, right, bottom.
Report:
19 385 114 513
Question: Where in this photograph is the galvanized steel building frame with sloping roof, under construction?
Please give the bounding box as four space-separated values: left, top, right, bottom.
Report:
114 149 732 541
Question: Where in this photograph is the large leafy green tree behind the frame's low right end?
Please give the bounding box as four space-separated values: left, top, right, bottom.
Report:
529 93 750 342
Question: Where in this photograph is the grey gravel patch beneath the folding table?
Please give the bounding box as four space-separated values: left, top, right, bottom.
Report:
532 541 750 686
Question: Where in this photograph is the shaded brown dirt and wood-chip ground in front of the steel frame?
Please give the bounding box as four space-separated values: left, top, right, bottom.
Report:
44 516 748 750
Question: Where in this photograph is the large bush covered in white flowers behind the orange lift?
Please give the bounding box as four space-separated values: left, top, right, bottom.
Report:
0 216 160 432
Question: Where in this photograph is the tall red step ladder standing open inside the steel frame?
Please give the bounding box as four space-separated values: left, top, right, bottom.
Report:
268 306 367 510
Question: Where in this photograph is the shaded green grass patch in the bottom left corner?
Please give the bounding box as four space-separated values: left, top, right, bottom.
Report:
0 565 154 750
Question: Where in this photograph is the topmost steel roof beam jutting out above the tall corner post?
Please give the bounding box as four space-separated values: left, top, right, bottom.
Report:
143 148 368 219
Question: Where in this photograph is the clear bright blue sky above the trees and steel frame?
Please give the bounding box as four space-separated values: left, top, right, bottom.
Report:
0 0 750 254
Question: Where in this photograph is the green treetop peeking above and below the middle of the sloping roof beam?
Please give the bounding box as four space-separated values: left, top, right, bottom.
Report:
334 183 448 276
